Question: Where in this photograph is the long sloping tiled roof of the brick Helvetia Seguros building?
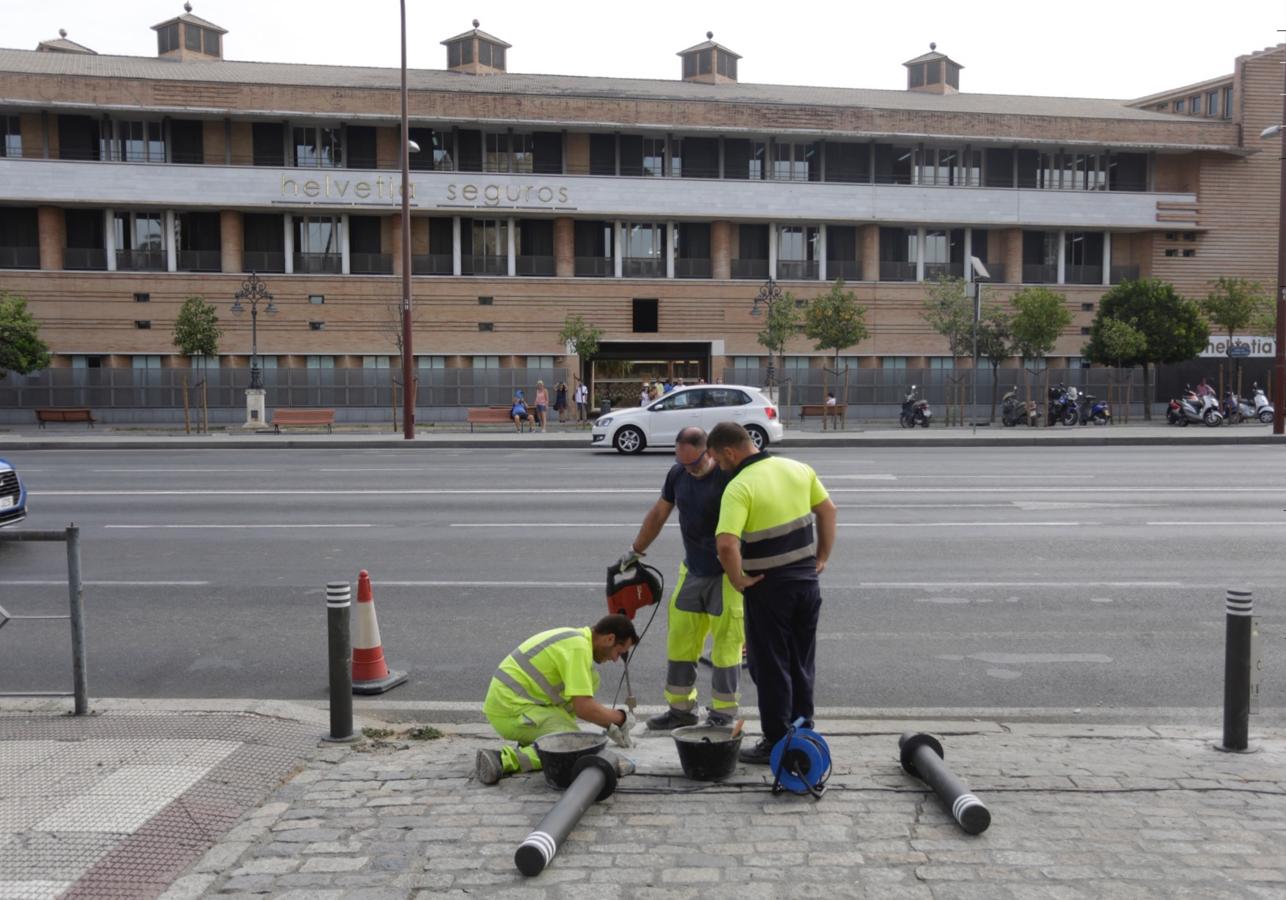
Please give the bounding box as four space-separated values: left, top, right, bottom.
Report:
0 49 1187 121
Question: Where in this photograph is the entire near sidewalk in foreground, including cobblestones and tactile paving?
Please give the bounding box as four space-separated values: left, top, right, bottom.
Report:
0 701 1286 900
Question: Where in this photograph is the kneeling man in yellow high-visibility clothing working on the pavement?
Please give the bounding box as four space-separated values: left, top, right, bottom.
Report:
476 616 639 784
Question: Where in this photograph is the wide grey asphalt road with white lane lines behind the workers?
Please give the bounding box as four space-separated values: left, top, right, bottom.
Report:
0 446 1286 715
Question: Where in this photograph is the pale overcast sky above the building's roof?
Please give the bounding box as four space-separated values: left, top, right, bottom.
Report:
0 0 1286 98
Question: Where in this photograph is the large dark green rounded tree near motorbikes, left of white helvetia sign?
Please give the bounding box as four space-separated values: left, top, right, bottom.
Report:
1085 278 1210 420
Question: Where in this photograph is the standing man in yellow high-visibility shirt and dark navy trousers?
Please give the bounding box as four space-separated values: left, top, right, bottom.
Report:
706 422 837 765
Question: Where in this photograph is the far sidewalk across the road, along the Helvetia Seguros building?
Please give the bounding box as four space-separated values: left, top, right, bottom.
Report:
0 419 1286 453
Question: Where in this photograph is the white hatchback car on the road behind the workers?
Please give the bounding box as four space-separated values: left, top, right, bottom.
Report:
589 384 784 453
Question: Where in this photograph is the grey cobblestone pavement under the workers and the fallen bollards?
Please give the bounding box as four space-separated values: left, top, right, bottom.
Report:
155 720 1286 900
